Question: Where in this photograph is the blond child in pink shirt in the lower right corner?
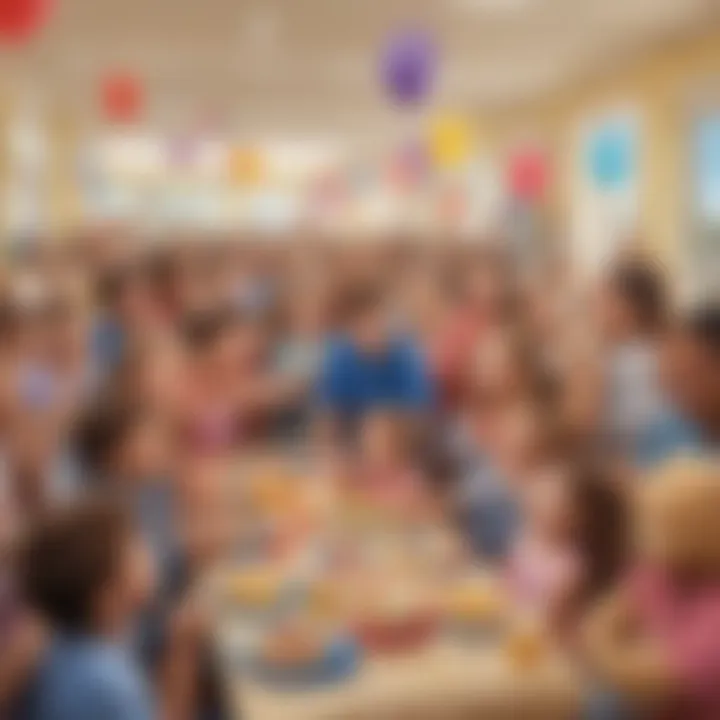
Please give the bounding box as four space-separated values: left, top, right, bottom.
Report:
586 459 720 720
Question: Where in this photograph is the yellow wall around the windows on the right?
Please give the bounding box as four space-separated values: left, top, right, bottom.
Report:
483 30 720 266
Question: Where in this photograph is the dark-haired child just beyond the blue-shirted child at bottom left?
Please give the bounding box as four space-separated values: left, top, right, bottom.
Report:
76 402 225 718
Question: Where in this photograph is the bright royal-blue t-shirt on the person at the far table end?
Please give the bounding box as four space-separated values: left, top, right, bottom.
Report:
318 337 433 420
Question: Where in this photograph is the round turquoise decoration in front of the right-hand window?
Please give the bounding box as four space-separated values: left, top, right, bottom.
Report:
587 122 635 190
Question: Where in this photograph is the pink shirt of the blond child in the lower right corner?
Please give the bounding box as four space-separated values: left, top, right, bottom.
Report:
631 567 720 720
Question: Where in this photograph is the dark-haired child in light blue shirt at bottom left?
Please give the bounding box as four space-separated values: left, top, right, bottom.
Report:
18 502 156 720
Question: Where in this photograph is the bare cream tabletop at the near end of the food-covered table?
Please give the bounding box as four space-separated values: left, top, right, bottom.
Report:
208 456 581 720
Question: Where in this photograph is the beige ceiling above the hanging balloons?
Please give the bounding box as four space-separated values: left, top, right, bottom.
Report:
0 0 718 135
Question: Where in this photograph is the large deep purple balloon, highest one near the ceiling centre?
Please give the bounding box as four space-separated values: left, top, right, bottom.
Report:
382 30 436 105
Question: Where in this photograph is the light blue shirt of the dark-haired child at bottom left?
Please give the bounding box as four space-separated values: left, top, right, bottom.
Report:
18 637 155 720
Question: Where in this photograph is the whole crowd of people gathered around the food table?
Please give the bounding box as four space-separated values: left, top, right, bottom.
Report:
0 228 720 720
